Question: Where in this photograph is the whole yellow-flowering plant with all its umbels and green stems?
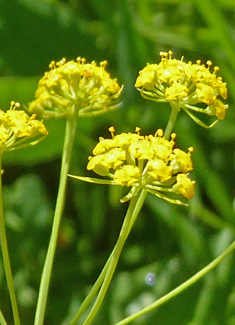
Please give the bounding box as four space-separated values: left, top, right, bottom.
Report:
0 51 235 325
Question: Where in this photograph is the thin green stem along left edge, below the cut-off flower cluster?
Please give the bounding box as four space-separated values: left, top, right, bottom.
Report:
0 153 20 325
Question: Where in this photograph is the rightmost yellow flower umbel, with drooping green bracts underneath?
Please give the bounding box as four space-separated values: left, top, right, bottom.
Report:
135 51 228 127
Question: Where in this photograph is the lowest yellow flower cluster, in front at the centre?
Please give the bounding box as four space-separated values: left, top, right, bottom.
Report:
87 127 195 204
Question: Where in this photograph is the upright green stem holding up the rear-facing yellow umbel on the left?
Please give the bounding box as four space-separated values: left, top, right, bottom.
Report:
34 109 78 325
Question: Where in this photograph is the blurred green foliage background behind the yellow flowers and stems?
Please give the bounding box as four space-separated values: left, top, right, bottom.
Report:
0 0 235 325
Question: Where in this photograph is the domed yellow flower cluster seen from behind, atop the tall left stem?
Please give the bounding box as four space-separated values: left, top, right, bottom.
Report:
29 58 121 118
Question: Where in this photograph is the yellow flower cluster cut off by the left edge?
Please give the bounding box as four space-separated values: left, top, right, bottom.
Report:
0 102 48 152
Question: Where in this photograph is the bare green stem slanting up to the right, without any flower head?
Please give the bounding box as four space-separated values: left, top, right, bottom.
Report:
115 241 235 325
